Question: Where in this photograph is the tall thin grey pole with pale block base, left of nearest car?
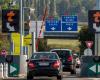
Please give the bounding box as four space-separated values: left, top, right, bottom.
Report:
19 0 27 76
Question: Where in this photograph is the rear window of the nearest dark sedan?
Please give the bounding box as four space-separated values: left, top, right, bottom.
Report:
31 53 58 60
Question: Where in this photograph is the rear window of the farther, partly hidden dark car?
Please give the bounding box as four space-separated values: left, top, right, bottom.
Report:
52 50 71 58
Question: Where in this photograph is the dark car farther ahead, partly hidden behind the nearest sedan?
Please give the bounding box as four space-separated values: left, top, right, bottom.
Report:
50 49 76 74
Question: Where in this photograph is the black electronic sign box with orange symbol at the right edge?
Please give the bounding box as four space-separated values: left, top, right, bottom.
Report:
88 10 100 34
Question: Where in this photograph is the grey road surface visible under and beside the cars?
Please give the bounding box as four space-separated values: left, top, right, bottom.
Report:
0 69 100 80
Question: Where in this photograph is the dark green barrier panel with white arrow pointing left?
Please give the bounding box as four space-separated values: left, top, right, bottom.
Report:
80 56 100 77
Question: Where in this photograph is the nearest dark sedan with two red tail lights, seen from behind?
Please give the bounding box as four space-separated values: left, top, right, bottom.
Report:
26 52 62 80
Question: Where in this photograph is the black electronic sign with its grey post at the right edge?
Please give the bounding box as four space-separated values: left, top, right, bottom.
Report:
88 10 100 56
